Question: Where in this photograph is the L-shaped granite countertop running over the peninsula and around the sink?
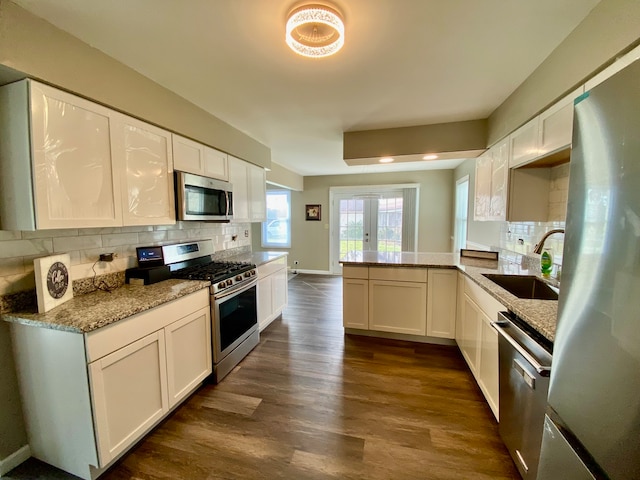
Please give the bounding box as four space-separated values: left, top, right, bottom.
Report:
340 252 558 342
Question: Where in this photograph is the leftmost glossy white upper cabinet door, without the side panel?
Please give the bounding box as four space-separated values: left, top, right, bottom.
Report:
31 82 122 229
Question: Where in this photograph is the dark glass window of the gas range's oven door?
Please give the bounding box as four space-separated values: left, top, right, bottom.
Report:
218 287 258 352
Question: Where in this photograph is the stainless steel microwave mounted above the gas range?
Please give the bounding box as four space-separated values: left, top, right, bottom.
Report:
176 172 233 222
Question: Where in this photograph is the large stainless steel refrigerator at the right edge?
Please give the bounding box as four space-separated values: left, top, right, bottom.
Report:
537 58 640 480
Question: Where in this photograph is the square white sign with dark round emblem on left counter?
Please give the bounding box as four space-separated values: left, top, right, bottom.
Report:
33 253 73 313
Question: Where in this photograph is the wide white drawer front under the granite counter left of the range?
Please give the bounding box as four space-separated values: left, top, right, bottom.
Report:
85 288 209 362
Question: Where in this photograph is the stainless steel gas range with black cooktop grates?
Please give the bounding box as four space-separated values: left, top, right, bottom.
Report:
158 240 260 383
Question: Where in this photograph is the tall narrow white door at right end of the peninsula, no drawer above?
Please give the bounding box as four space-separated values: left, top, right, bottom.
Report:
427 269 458 338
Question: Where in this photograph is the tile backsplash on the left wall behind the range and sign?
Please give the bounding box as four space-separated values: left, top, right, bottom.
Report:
0 222 251 295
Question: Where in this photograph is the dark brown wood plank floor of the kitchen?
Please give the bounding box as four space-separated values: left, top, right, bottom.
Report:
7 274 519 480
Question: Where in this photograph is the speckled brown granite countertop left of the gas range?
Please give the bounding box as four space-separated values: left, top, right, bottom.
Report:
2 279 211 333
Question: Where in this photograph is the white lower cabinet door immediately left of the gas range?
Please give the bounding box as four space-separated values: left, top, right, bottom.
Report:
165 307 212 408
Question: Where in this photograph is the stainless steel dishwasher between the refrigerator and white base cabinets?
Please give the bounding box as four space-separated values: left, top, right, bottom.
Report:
492 312 551 480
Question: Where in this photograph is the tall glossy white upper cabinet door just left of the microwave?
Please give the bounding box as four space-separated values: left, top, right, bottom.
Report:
112 115 176 229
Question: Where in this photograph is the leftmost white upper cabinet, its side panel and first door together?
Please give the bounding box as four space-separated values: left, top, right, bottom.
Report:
0 80 122 230
